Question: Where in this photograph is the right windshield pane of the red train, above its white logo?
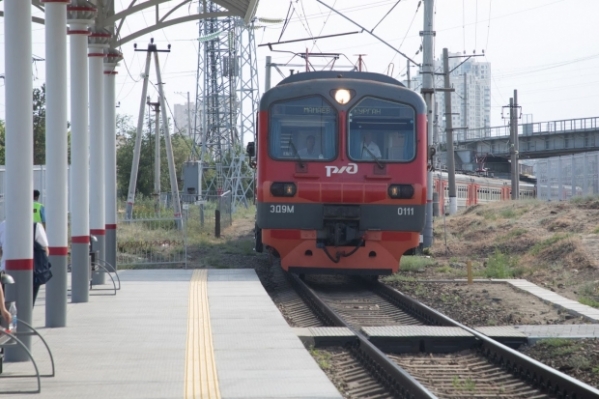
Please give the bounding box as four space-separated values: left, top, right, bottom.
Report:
347 97 416 162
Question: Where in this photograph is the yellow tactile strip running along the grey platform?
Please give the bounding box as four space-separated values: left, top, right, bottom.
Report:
184 270 220 399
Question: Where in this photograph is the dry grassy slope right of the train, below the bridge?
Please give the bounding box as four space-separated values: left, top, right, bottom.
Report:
428 197 599 305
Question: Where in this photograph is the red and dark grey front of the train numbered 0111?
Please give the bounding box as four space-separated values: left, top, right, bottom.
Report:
256 72 427 275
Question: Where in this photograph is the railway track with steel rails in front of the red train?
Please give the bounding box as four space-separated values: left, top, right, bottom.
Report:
288 276 599 399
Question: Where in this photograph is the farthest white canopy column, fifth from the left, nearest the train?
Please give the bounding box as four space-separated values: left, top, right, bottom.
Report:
104 49 123 271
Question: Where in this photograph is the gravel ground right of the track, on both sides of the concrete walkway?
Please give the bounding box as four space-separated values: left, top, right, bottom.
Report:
387 281 599 387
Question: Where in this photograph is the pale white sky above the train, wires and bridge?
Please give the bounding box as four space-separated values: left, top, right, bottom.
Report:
0 0 599 131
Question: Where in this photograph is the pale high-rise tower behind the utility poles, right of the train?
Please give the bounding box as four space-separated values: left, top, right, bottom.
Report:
404 53 491 142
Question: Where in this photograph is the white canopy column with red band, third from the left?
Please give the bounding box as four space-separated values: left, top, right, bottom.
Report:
67 1 97 303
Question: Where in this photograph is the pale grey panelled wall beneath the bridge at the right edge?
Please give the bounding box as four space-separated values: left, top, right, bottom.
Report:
535 152 599 201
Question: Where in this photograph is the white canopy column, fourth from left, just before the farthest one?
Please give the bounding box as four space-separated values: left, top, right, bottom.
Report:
87 28 111 285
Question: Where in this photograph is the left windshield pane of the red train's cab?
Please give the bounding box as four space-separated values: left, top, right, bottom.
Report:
268 96 337 161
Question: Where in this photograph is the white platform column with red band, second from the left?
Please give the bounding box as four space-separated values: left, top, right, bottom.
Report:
42 0 70 327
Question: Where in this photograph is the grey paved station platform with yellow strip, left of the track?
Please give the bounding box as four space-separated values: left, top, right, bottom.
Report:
0 269 341 399
